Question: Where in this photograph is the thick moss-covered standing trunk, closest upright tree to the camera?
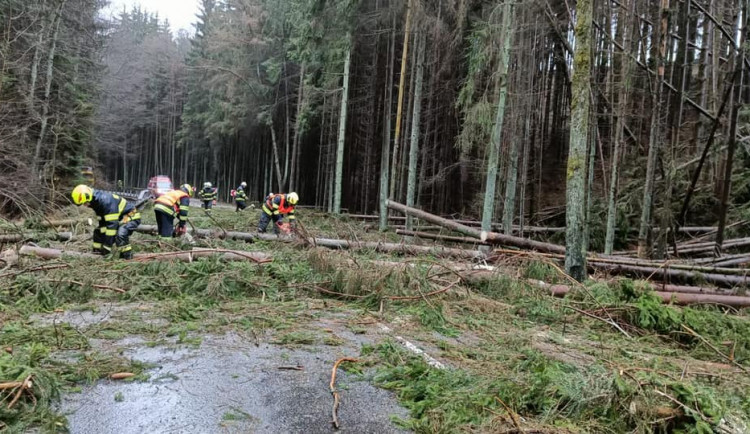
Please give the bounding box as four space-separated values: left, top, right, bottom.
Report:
565 0 592 282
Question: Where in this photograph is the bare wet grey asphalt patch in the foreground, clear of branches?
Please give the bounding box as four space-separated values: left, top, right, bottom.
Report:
62 333 408 434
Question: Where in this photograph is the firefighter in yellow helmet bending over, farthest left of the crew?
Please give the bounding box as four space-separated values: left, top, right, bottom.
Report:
71 184 141 259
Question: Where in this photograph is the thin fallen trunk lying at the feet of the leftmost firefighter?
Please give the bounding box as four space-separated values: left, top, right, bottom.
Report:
18 245 273 263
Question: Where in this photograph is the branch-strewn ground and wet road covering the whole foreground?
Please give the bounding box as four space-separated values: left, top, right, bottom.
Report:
0 207 750 433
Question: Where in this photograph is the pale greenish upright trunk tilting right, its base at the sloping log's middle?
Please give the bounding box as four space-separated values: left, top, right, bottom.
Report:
482 0 515 236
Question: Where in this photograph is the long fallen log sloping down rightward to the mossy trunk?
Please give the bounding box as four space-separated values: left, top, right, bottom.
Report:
387 200 565 254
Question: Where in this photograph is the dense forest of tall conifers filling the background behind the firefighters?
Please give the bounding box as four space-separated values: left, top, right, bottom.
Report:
0 0 750 264
